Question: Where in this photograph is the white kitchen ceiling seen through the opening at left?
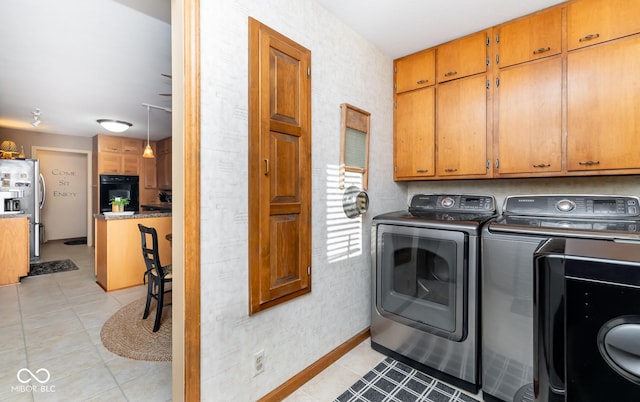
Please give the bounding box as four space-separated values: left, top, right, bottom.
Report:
0 0 171 140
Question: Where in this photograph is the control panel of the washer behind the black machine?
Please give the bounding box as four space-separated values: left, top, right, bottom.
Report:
503 195 640 219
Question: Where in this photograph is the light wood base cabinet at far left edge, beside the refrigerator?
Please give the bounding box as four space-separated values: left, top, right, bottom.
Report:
0 215 29 286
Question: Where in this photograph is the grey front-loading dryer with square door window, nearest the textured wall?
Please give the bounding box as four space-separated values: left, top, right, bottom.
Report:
371 194 495 392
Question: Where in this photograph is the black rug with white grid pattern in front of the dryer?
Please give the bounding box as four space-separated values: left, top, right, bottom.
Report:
334 357 479 402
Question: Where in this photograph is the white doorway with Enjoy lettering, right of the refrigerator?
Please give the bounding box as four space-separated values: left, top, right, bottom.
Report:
32 147 93 246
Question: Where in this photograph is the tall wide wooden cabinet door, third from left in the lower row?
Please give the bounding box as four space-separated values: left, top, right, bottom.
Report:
497 57 562 174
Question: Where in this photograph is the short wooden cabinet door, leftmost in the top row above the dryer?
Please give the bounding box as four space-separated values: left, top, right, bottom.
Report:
395 49 436 93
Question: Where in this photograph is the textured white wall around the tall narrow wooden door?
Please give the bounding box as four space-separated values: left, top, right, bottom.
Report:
200 0 406 401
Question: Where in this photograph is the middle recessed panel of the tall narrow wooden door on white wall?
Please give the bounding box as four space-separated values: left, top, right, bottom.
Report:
269 132 300 204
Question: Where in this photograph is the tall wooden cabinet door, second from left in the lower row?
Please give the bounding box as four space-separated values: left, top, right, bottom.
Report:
436 75 488 176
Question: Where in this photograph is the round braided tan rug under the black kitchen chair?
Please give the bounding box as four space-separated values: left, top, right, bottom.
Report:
100 298 171 362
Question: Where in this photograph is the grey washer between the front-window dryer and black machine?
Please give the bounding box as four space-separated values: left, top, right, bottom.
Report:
481 194 640 402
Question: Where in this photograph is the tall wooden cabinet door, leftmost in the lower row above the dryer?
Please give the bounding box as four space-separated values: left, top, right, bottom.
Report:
393 87 435 180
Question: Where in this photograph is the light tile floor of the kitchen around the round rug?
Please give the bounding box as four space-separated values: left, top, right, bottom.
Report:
0 241 171 402
